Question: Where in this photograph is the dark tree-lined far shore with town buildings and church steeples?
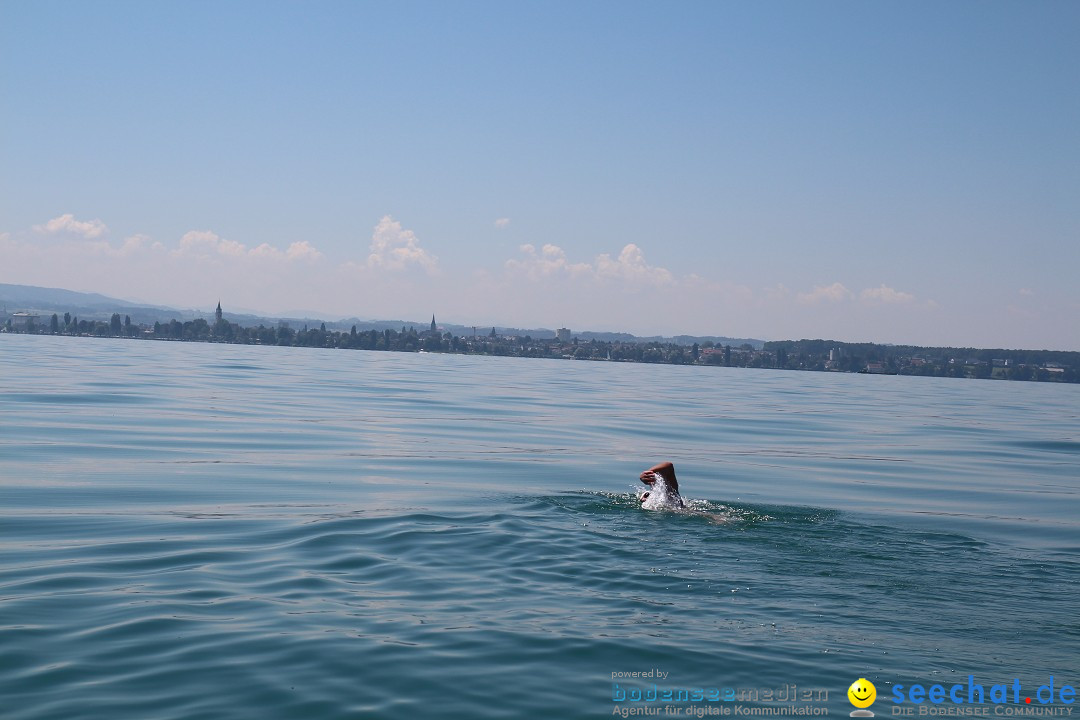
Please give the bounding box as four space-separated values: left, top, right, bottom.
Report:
8 303 1080 382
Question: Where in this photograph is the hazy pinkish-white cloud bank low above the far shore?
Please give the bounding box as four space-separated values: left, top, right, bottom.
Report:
0 214 989 341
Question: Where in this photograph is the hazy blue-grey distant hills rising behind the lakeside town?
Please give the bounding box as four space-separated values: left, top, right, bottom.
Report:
0 283 764 349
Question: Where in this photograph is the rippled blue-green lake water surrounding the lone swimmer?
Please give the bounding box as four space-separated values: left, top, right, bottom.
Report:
0 335 1080 720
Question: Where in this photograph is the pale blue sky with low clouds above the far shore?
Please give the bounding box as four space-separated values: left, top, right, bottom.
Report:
0 0 1080 350
